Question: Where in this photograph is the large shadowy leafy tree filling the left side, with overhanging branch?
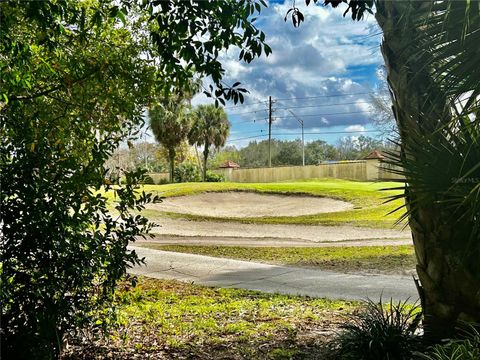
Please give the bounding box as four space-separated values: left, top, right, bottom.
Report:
0 0 271 359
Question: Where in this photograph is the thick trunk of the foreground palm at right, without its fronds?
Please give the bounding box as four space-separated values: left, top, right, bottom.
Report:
376 0 480 341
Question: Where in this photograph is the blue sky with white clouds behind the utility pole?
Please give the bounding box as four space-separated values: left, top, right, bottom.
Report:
144 0 382 148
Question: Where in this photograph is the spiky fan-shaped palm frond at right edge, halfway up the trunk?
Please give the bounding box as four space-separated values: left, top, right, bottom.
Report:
385 117 480 237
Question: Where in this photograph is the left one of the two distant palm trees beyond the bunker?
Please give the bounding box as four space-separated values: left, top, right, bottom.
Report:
148 95 192 182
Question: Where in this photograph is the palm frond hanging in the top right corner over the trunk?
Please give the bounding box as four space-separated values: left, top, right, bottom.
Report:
417 0 480 115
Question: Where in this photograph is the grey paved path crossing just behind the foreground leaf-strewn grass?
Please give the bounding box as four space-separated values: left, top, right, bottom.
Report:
130 246 418 302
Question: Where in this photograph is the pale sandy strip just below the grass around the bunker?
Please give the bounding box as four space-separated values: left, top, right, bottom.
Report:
152 218 412 243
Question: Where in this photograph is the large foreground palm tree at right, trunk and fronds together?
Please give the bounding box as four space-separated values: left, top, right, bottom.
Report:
375 0 480 339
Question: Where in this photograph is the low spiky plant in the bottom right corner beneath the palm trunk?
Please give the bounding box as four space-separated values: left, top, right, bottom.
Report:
418 325 480 360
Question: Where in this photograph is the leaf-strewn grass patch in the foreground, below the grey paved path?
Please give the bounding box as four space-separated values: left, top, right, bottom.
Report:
66 278 360 360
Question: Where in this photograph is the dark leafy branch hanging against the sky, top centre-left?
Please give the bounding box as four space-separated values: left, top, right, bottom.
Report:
131 0 272 104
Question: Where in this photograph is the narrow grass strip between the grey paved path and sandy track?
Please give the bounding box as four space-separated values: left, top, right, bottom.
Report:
142 243 416 274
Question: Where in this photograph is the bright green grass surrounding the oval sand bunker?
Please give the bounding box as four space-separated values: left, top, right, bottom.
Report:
131 179 403 228
